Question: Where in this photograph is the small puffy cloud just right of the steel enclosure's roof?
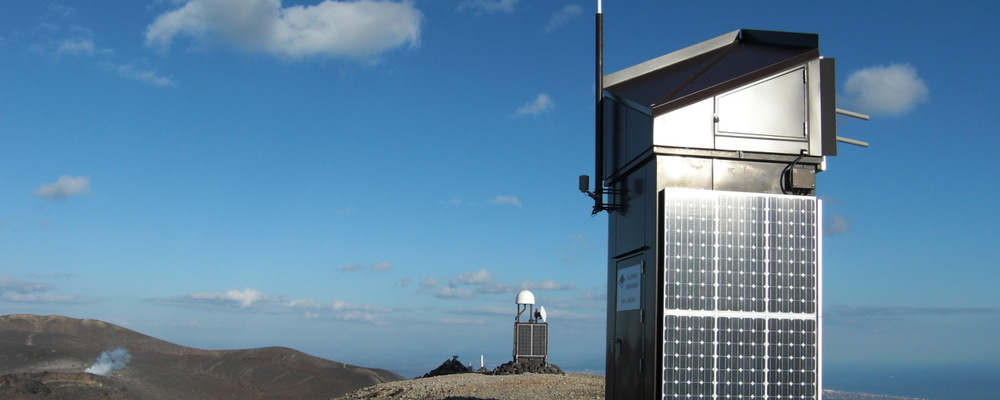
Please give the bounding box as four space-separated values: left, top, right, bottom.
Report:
844 64 930 115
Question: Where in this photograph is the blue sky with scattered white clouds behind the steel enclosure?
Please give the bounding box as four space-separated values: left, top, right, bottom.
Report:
0 0 1000 398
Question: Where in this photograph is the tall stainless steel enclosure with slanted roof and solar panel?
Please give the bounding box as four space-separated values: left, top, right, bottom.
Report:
598 30 836 399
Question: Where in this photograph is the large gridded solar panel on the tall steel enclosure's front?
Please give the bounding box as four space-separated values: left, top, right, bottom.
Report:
662 189 820 399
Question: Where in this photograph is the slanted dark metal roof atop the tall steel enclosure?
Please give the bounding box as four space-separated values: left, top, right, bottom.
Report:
604 29 819 115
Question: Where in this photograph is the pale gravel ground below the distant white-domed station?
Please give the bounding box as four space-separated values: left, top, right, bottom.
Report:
335 373 604 400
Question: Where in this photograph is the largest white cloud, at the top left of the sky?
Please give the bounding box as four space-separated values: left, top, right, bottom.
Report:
146 0 423 59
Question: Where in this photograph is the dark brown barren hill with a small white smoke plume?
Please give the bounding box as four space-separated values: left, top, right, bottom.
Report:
0 315 403 400
